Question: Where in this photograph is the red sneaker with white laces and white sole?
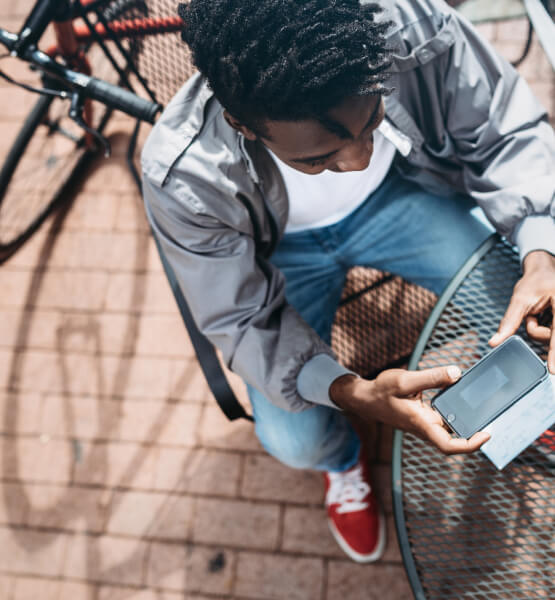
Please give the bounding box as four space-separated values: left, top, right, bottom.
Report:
325 460 385 563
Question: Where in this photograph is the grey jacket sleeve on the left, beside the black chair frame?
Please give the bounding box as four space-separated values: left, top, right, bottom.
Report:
143 177 348 412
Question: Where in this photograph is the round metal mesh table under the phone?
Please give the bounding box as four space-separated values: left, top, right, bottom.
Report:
393 235 555 600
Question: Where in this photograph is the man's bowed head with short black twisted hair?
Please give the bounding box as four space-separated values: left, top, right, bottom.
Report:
179 0 390 173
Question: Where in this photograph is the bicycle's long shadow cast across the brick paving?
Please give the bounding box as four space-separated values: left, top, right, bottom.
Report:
2 146 264 600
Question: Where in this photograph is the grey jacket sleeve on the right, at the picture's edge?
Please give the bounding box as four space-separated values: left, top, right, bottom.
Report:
443 12 555 257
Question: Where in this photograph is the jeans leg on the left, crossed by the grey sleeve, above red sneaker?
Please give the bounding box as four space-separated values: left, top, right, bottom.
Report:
249 227 359 471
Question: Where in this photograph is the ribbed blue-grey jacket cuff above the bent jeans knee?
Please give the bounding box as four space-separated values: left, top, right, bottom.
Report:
297 354 358 410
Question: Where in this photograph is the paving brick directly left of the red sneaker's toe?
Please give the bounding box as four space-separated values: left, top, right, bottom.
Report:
282 506 344 558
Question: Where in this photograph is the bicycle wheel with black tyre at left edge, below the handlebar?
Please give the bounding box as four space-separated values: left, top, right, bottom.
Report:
0 91 92 263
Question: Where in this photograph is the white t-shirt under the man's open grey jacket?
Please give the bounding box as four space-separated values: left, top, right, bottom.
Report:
270 130 395 233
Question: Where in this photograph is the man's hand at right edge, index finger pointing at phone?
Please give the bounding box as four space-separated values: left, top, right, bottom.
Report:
489 250 555 373
